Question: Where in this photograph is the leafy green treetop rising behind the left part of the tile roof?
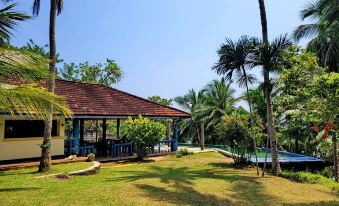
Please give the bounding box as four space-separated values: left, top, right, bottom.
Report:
60 58 123 86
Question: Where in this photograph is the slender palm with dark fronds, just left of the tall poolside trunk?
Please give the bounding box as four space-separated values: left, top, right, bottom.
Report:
212 36 259 175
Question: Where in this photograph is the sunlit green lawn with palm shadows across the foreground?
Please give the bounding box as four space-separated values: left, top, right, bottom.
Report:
0 153 339 205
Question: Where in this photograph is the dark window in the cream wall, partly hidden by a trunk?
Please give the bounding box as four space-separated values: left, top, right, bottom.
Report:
5 120 58 138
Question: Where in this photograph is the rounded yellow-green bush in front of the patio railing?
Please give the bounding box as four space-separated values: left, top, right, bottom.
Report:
122 115 166 159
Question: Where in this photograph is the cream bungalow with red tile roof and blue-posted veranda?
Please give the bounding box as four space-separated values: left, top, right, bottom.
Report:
0 80 190 161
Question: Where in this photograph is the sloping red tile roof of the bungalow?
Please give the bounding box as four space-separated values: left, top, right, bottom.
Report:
55 80 190 118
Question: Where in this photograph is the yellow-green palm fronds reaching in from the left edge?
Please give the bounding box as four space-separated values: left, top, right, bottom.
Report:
0 4 70 119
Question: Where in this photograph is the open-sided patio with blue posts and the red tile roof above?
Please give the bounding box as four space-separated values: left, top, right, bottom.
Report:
55 80 190 160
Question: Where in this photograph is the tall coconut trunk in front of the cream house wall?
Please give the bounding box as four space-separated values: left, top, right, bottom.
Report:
39 0 57 172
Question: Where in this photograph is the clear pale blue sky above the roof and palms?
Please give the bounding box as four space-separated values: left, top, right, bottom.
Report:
11 0 307 107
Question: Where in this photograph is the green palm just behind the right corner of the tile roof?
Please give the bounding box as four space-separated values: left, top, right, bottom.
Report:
174 89 204 149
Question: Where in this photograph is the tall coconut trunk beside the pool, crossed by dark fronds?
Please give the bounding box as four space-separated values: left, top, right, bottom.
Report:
258 0 281 176
